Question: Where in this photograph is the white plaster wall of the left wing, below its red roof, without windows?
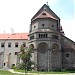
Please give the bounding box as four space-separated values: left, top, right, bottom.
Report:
0 40 28 67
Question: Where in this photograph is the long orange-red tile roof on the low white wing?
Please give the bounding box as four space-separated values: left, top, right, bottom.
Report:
0 33 28 40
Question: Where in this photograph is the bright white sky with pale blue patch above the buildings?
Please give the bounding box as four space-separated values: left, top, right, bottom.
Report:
0 0 75 41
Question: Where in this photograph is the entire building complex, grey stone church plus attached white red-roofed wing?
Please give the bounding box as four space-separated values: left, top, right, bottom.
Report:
0 4 75 71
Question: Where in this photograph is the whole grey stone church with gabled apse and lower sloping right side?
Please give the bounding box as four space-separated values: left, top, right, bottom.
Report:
28 4 75 71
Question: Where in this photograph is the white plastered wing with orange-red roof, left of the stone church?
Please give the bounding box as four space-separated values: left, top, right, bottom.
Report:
0 33 28 68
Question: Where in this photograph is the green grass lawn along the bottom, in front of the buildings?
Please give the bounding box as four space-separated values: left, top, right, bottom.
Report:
0 70 75 75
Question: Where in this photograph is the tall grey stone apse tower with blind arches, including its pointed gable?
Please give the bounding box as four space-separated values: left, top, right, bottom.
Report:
29 4 62 71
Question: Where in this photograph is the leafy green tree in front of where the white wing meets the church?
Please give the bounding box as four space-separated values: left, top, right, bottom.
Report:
18 45 33 71
